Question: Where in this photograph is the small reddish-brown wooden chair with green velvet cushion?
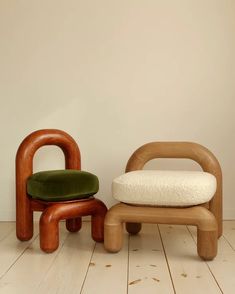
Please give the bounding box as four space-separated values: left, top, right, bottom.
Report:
16 129 107 252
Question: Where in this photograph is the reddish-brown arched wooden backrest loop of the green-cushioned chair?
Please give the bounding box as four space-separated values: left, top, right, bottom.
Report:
16 129 81 240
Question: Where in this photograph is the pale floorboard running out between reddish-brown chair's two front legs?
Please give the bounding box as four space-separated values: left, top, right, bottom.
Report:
35 223 95 294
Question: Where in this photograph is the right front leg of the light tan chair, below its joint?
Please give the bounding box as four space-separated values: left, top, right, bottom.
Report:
197 228 218 260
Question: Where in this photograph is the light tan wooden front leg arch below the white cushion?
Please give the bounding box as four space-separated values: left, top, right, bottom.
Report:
104 203 217 260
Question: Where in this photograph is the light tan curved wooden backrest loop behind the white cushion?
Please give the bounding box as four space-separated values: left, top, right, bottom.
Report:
126 142 222 236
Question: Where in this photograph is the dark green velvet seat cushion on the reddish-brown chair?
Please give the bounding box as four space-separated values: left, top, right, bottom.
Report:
27 169 99 201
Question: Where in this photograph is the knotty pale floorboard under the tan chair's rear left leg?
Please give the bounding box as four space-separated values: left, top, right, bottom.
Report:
128 224 174 294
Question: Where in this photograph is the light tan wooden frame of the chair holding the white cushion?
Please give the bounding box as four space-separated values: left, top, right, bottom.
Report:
104 142 222 260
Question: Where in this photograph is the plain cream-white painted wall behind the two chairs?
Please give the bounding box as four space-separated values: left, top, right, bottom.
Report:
0 0 235 220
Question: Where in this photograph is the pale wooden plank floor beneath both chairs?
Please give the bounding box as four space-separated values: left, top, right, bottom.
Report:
0 221 235 294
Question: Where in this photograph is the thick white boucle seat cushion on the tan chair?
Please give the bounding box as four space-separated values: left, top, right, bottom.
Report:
112 170 216 206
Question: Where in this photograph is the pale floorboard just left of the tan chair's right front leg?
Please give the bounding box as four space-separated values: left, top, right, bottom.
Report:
159 225 221 294
